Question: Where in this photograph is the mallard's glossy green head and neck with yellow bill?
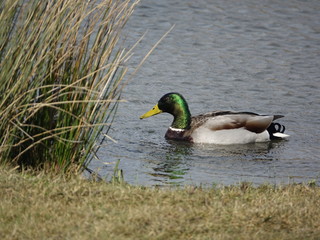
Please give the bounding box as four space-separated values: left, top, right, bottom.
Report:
140 93 191 129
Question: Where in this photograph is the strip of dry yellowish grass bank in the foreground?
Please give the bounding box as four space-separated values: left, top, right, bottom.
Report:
0 170 320 239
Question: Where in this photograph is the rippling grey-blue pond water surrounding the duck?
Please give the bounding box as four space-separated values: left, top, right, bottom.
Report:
91 0 320 186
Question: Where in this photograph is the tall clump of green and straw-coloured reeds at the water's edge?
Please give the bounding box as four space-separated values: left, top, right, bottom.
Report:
0 0 137 173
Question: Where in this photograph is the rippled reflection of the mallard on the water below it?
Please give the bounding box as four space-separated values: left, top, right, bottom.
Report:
149 140 283 185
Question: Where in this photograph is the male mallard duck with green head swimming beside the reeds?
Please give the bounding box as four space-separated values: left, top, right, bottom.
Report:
140 93 289 144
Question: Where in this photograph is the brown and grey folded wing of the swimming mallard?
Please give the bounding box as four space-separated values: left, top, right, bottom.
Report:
191 111 283 133
